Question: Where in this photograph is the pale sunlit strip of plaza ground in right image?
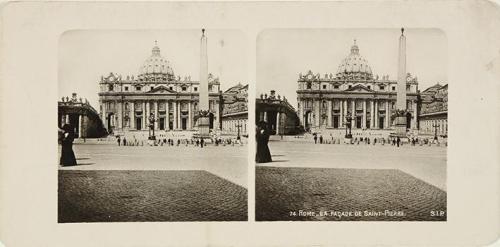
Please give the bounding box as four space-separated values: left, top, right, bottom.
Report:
258 141 446 191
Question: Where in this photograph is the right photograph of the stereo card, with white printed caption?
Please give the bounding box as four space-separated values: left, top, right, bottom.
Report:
255 28 449 221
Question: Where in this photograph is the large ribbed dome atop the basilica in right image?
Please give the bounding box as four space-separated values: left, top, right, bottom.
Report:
337 40 373 79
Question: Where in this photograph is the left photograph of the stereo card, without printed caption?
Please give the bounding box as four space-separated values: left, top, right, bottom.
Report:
57 28 248 223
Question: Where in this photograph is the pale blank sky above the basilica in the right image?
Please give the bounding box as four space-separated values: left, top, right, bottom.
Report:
256 29 448 107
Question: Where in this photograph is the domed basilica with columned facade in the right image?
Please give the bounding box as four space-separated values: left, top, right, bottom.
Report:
297 41 419 132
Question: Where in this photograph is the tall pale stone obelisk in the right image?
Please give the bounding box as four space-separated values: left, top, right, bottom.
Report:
395 28 407 138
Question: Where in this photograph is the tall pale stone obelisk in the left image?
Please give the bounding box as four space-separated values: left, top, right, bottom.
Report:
197 29 210 138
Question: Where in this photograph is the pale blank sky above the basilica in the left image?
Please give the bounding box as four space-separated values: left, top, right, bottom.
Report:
58 28 248 109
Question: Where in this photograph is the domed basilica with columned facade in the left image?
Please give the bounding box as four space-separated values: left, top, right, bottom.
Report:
99 45 222 133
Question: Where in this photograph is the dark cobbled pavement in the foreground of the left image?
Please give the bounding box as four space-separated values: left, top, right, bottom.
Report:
58 170 247 223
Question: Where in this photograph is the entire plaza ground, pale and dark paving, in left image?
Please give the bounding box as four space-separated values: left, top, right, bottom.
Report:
58 142 248 222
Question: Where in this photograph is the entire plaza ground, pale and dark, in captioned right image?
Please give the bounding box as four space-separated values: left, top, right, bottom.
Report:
255 140 446 221
